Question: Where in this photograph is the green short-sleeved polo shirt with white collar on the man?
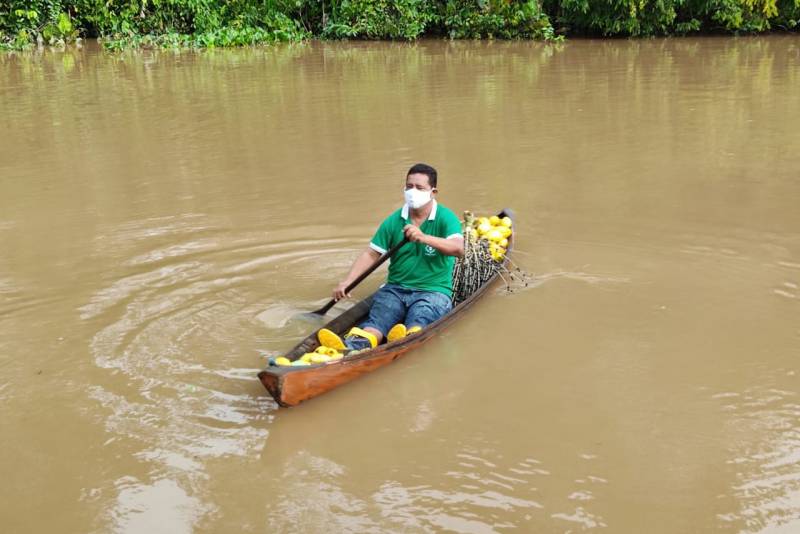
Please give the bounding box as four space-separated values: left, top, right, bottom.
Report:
369 200 462 297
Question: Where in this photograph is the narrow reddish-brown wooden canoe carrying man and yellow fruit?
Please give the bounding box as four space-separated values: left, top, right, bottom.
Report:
258 210 514 407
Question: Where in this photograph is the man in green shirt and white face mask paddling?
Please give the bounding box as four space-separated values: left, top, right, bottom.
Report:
317 163 464 356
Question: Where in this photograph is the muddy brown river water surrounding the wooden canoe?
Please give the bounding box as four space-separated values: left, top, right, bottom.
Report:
0 36 800 534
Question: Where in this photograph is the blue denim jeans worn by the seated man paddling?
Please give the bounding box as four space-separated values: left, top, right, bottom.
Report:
345 284 453 350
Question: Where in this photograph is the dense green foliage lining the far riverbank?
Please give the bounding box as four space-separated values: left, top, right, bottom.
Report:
0 0 800 49
